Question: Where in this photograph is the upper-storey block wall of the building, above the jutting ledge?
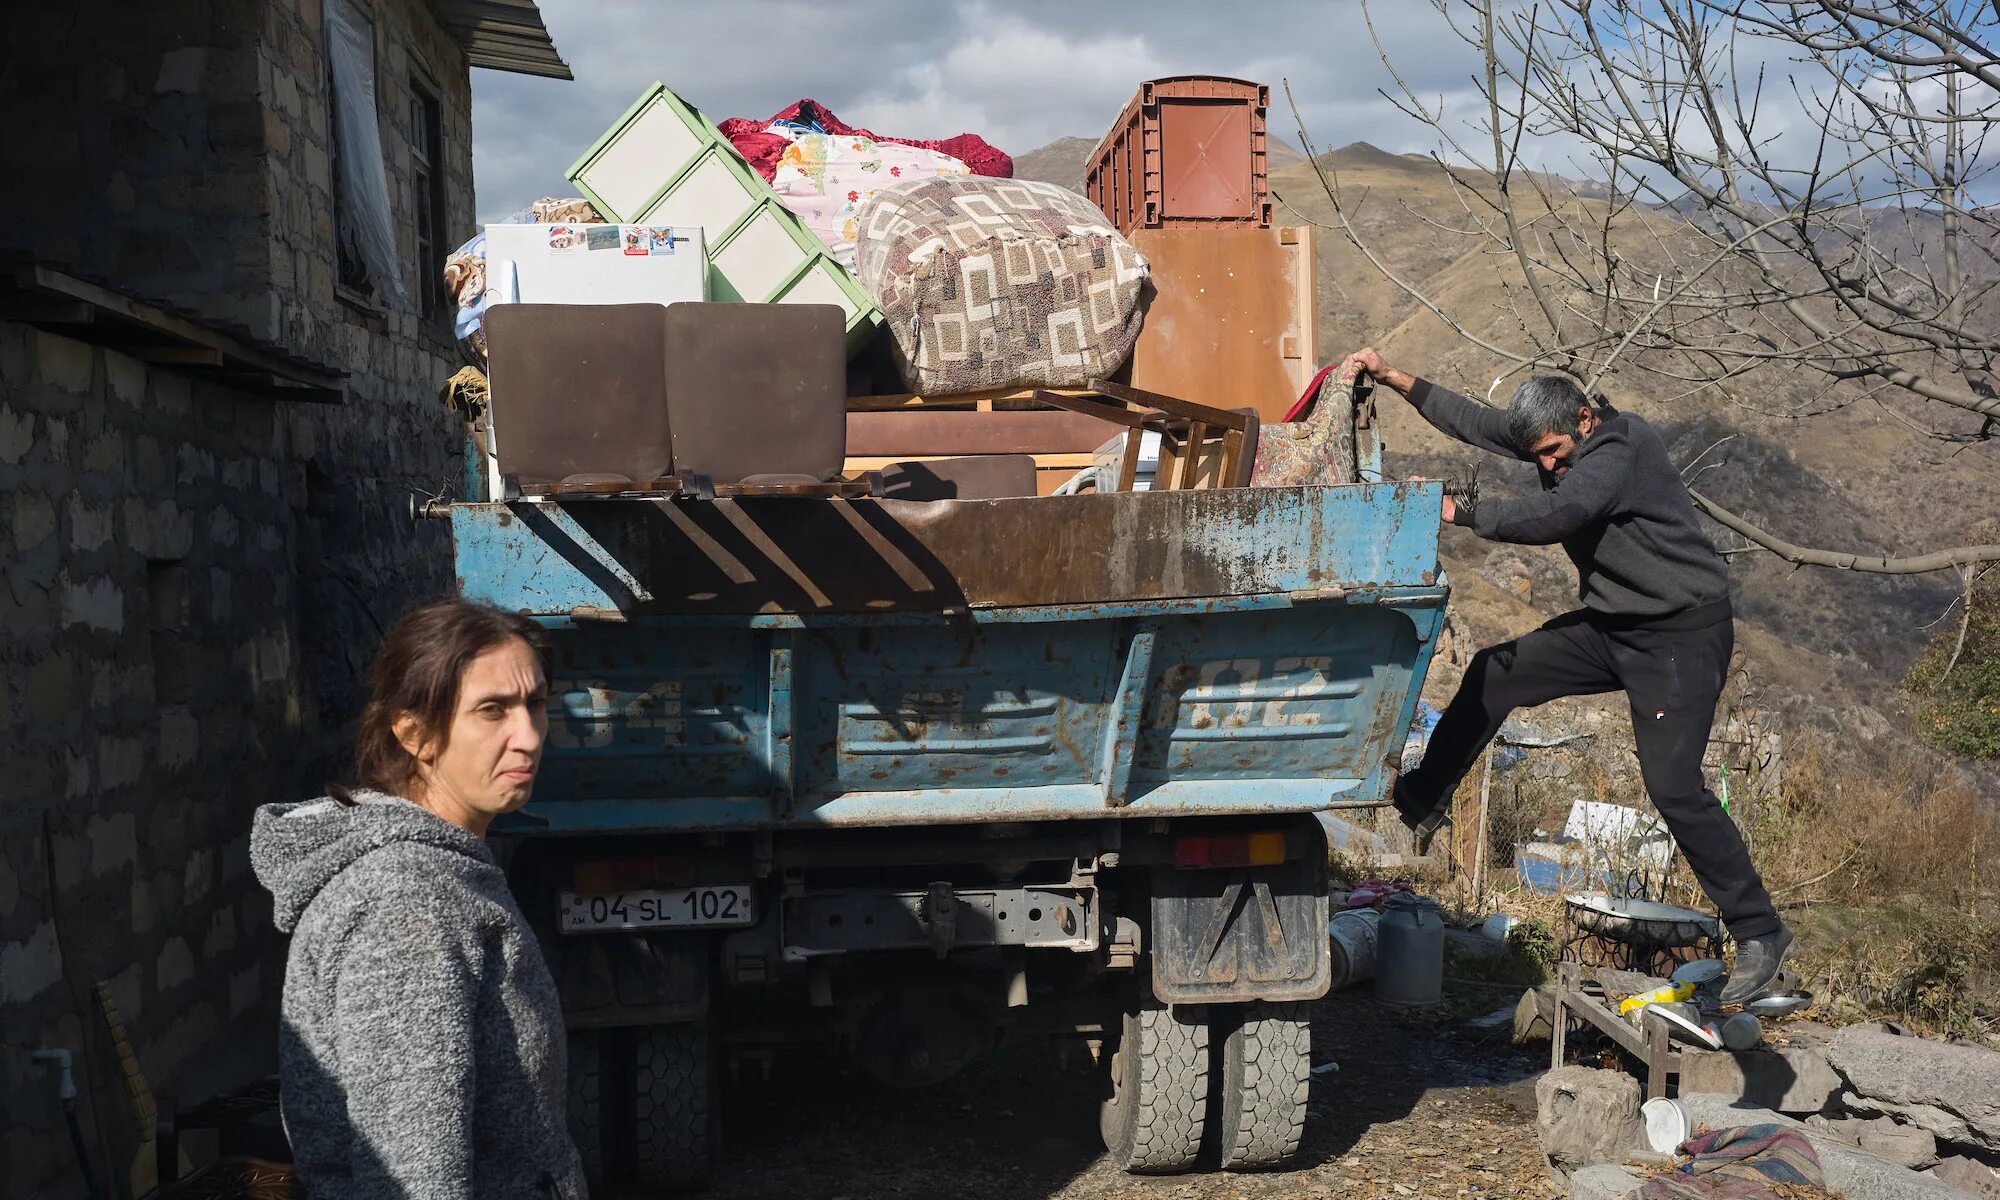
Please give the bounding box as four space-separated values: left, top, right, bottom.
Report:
0 0 474 366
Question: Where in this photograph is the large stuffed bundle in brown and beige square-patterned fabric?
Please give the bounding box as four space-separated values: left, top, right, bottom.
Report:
856 176 1146 396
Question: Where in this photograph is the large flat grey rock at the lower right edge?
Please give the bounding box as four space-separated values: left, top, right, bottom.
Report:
1828 1026 2000 1150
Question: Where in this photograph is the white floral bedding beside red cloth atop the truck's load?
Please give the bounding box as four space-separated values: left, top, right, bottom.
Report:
770 126 972 270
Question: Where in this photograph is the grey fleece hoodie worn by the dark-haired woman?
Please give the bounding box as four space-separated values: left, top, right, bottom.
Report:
250 792 584 1200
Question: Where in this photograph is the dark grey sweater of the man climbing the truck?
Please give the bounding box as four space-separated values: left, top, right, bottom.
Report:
1410 380 1730 626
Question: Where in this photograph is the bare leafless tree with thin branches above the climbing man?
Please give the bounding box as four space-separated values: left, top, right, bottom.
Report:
1294 0 2000 574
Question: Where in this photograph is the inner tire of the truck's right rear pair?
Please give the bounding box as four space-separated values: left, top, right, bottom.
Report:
1098 1002 1208 1174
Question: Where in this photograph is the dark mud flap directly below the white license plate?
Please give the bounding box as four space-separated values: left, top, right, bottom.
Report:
554 934 708 1030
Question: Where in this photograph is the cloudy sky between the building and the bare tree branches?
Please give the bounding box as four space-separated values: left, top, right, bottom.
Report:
472 0 1504 220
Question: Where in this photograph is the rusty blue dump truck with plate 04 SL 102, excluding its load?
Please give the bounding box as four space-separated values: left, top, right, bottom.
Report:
426 454 1448 1190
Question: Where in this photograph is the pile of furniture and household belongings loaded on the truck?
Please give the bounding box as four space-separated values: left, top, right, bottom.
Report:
446 76 1360 498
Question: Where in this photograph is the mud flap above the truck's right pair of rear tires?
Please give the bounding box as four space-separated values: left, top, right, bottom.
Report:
1152 858 1332 1004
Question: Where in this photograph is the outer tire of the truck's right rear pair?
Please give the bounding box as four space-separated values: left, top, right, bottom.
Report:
1216 1000 1312 1170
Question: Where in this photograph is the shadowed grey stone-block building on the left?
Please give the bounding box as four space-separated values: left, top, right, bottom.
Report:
0 0 568 1198
